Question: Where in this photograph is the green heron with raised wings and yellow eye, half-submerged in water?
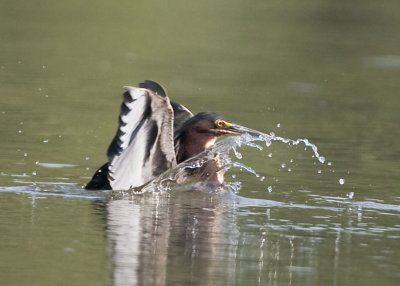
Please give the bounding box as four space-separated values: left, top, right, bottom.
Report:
85 80 244 190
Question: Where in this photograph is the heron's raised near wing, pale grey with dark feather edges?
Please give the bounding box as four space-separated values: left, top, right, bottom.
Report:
107 82 176 190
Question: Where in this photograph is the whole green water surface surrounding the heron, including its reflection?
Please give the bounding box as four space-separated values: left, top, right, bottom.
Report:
0 0 400 286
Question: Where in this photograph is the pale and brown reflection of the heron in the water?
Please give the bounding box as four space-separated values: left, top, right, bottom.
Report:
107 191 237 285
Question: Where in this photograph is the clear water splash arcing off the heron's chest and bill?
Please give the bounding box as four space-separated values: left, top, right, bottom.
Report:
139 125 325 193
